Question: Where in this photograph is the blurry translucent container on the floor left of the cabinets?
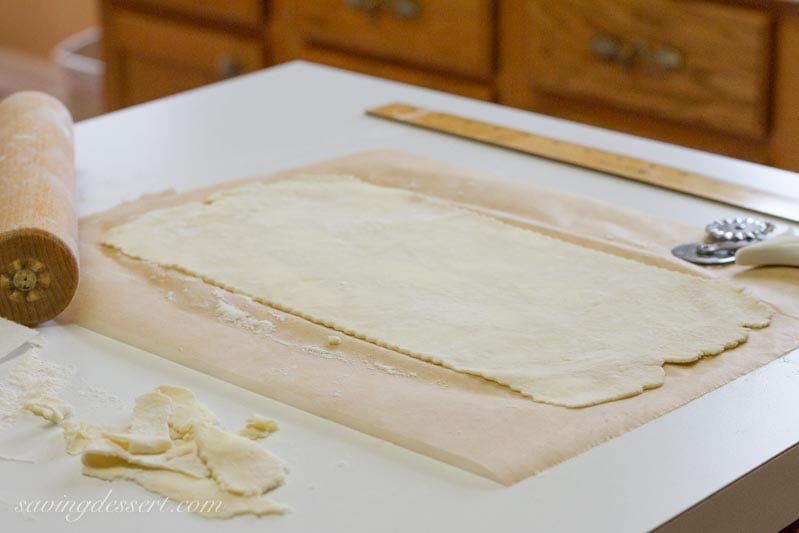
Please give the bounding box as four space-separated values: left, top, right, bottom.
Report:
52 28 105 121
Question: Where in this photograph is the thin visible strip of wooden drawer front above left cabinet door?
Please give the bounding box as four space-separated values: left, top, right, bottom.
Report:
117 0 263 27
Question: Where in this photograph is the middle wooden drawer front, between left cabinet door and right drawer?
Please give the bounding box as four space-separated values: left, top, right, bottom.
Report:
296 0 494 80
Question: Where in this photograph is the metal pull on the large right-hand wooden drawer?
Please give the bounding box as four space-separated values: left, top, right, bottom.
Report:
588 34 685 70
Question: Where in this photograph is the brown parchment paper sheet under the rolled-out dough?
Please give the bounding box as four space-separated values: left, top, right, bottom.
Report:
62 151 799 484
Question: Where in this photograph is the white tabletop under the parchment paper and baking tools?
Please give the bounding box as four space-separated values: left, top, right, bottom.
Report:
0 62 799 533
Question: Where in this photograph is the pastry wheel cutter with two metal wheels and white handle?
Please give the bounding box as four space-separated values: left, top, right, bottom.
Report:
671 217 799 267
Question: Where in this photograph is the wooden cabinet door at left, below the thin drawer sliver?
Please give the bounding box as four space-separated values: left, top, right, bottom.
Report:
105 8 265 109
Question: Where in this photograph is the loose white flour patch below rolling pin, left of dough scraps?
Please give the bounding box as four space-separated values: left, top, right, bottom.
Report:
0 338 75 429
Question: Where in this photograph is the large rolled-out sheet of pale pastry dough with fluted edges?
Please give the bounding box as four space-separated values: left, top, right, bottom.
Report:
104 175 771 407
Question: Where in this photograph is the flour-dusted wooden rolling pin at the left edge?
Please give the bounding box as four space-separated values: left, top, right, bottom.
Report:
0 92 78 326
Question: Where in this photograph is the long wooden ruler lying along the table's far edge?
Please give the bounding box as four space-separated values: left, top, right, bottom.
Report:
366 103 799 222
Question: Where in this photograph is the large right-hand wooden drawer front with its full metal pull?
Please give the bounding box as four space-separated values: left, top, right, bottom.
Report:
528 0 771 138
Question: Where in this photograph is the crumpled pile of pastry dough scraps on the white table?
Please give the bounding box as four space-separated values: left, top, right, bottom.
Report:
63 385 288 518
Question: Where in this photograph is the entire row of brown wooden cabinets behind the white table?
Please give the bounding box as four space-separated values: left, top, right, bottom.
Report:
103 0 799 174
